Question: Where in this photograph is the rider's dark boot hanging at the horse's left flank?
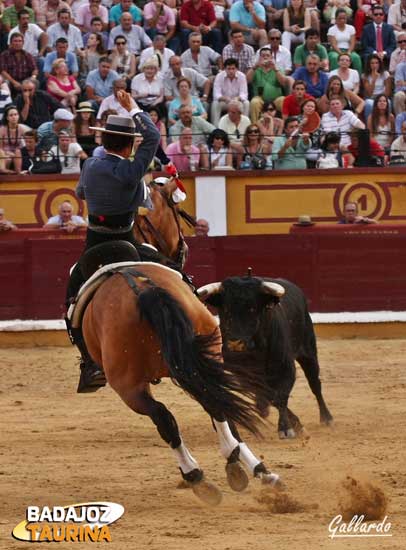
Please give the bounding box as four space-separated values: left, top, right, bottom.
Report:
65 319 106 393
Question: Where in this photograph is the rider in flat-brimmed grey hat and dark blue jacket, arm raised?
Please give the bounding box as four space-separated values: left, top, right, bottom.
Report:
66 90 174 393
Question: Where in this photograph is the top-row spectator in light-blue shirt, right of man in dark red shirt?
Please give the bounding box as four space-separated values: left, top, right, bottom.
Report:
229 0 267 47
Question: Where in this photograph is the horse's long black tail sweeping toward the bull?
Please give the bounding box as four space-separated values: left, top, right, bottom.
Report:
138 287 258 434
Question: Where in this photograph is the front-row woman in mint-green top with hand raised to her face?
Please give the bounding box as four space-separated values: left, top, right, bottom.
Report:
272 117 311 170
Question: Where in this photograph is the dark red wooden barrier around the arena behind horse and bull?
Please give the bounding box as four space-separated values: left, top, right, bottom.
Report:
0 229 406 319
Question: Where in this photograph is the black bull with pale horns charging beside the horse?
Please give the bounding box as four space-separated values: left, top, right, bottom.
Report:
198 276 333 438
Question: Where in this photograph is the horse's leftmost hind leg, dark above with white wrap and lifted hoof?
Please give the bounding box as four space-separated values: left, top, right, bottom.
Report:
120 389 221 505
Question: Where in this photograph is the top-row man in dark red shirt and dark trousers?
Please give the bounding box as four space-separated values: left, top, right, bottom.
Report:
179 0 223 53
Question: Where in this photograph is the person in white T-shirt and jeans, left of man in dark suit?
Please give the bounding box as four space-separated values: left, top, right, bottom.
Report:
327 9 362 75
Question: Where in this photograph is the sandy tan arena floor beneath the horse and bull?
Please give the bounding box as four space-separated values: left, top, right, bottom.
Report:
0 340 406 550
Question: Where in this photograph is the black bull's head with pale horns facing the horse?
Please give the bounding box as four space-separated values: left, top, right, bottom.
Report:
197 277 285 352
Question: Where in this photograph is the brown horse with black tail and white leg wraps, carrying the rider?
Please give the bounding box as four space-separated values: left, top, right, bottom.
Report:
77 177 280 505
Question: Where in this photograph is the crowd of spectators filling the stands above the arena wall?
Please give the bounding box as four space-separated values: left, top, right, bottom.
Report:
0 0 406 174
